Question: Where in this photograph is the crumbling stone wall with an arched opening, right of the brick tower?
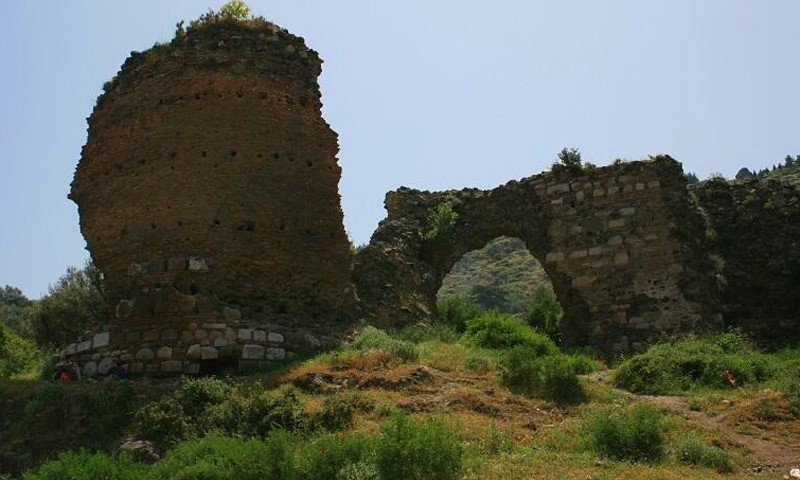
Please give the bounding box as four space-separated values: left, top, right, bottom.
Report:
354 156 721 352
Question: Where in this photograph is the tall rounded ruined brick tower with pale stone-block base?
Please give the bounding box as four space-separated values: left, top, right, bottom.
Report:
70 17 354 373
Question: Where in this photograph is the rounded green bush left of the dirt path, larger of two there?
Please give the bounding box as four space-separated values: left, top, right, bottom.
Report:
586 404 665 462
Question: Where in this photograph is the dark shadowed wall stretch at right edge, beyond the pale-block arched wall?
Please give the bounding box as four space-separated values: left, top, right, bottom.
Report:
691 179 800 344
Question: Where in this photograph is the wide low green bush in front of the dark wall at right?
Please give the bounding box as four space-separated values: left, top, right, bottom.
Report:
615 334 776 394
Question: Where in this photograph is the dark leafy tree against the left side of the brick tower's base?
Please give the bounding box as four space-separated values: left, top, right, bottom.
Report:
33 261 109 347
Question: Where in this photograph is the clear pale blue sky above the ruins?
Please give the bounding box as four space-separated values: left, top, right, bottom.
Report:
0 0 800 297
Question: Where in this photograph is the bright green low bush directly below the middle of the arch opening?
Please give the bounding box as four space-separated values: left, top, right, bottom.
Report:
464 312 560 356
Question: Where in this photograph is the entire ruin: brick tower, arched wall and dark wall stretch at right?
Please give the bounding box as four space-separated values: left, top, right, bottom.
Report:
62 15 800 376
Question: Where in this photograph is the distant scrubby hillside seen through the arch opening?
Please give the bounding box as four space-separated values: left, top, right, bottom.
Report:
439 237 552 314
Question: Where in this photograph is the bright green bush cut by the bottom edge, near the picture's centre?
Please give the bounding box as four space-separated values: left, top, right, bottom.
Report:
375 415 464 480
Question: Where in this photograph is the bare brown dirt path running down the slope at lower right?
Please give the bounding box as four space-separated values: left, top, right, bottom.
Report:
587 370 800 473
